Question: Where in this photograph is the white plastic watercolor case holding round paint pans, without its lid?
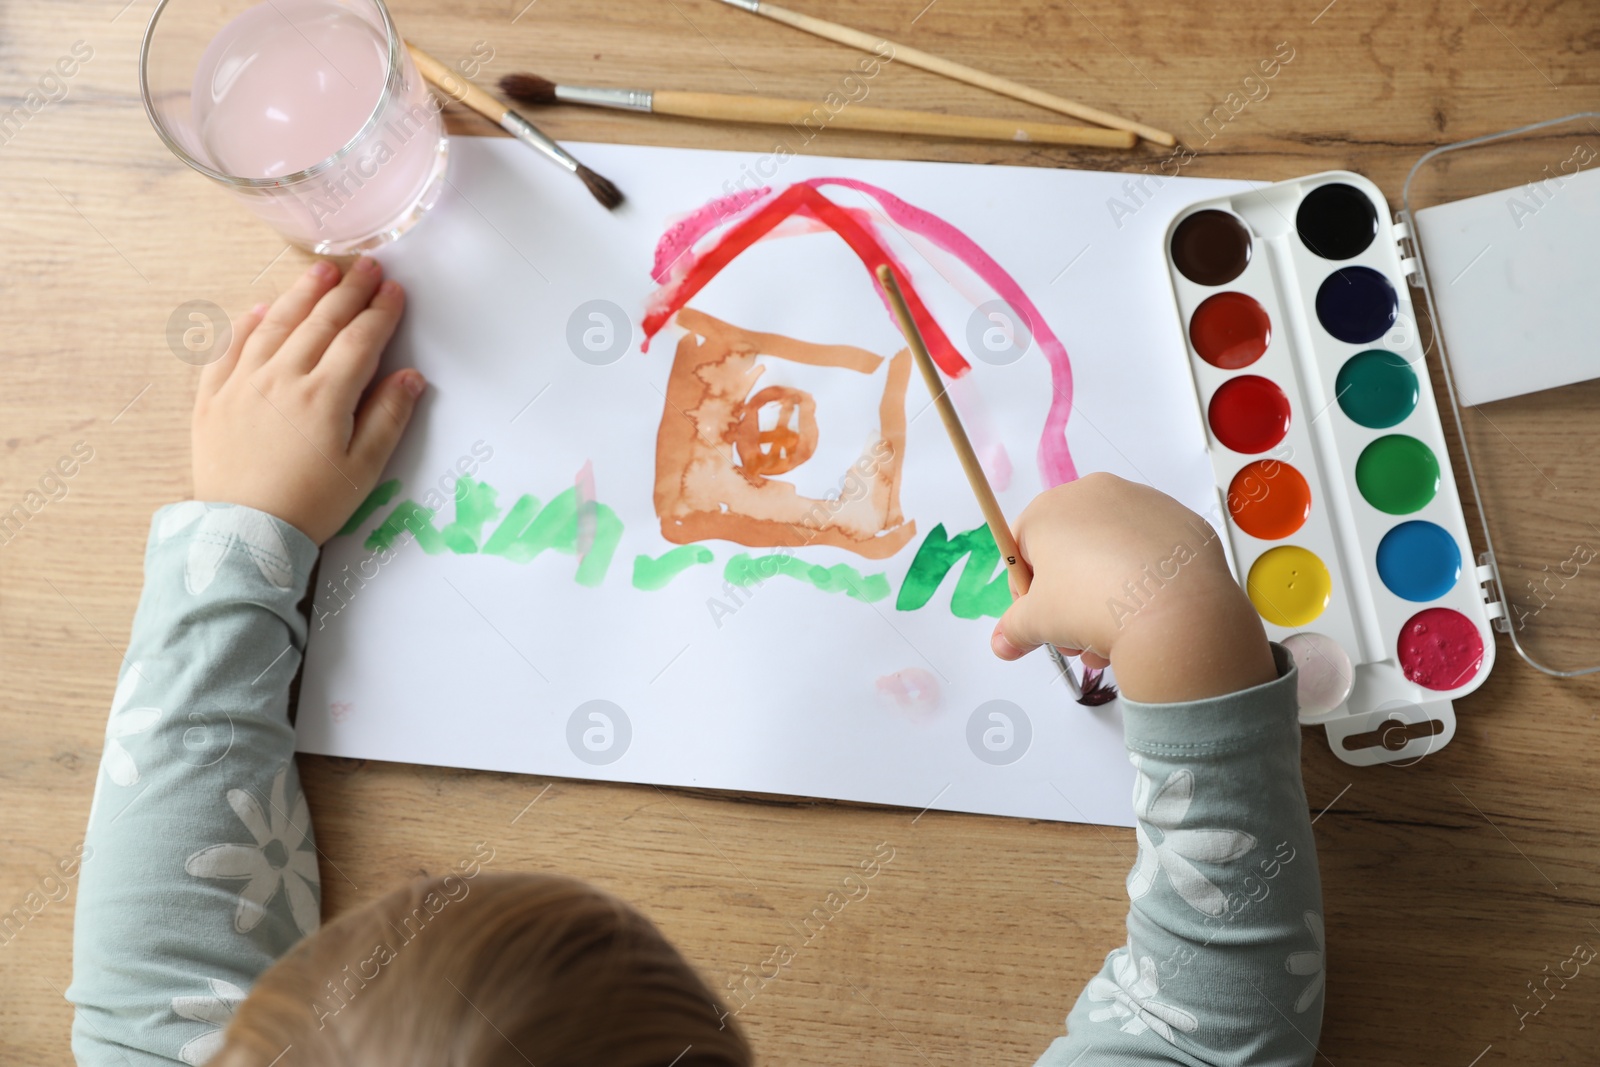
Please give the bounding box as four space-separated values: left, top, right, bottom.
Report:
1166 171 1494 763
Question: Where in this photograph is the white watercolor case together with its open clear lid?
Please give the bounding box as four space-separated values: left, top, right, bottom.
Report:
1163 112 1600 765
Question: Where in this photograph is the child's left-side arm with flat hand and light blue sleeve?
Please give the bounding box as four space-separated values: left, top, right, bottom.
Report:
67 261 422 1067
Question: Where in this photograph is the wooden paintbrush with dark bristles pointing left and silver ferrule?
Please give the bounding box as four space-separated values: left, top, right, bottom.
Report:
499 74 1139 149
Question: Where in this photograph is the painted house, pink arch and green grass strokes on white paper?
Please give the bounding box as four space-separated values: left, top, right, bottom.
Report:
341 178 1077 619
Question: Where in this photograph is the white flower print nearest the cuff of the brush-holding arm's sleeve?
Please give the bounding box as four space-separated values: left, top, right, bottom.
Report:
1128 755 1256 917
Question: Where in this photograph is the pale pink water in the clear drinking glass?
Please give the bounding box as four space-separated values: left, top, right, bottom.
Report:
192 0 445 251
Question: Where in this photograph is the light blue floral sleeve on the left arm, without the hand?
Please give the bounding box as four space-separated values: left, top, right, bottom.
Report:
67 501 322 1067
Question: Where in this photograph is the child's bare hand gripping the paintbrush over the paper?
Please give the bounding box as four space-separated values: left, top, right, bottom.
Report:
990 474 1277 704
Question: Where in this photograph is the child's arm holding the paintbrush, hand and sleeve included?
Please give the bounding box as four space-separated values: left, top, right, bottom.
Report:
994 475 1323 1067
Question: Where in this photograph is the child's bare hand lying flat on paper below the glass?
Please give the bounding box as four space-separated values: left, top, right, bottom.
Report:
194 256 427 544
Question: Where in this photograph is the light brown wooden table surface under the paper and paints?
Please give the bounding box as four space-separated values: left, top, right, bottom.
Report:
0 0 1600 1067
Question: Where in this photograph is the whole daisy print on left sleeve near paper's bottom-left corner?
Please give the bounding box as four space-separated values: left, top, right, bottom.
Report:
184 765 322 934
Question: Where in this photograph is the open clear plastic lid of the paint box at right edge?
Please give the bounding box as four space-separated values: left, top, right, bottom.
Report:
1397 112 1600 677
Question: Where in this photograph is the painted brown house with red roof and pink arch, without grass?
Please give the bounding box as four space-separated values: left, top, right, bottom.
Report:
645 178 1075 566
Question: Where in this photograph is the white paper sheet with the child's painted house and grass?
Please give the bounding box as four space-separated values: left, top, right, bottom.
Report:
298 138 1246 824
